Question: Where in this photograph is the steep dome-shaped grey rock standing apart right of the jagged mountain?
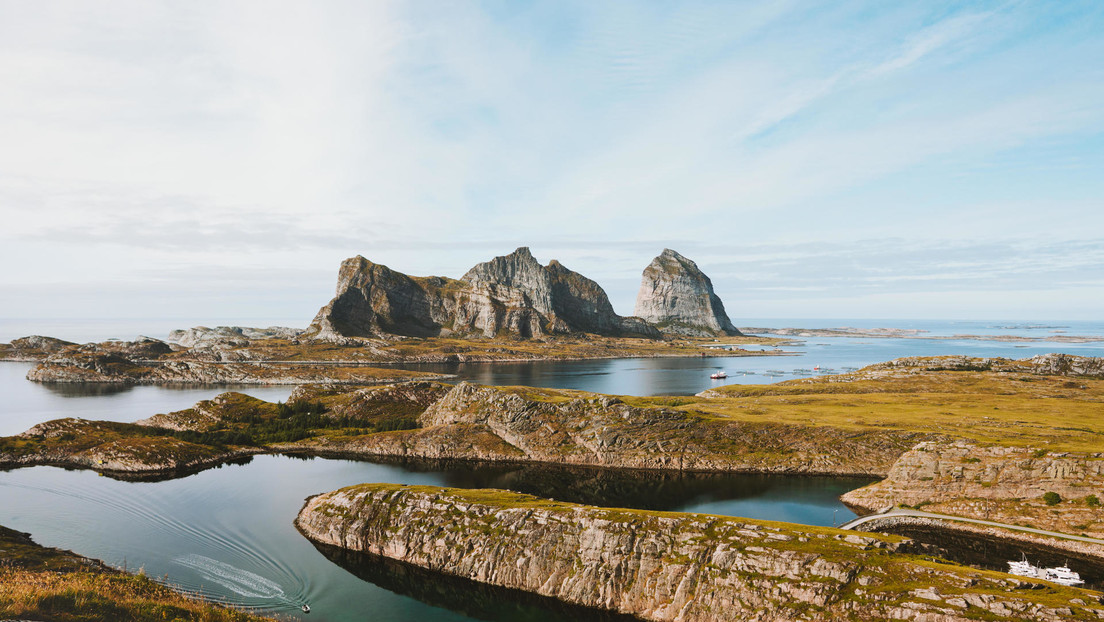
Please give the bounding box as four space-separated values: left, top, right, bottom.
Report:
633 249 741 337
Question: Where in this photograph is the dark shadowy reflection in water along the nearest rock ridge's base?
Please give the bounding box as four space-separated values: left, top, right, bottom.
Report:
314 542 639 622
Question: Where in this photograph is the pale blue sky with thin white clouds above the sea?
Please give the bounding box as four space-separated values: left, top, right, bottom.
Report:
0 0 1104 327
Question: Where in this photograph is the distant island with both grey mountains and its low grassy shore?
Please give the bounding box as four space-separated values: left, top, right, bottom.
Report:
0 247 779 384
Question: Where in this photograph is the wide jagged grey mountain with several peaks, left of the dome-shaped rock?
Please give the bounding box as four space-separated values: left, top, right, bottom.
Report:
306 246 659 341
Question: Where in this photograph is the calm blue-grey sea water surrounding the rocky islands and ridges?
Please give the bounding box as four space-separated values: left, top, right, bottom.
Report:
0 320 1104 621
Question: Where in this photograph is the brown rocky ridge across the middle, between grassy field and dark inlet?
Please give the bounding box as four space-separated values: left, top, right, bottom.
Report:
312 382 933 475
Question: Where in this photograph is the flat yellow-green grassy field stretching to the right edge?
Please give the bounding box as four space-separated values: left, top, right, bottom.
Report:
622 371 1104 452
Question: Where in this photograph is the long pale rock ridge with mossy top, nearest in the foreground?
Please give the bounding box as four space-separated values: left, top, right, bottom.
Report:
296 484 1104 622
